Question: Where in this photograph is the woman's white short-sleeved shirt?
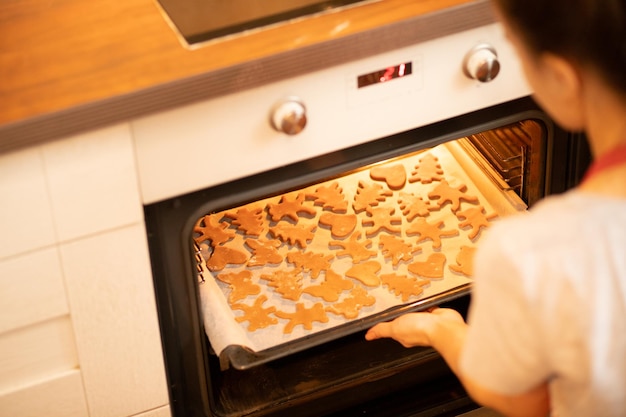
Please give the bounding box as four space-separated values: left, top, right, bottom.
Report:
460 190 626 417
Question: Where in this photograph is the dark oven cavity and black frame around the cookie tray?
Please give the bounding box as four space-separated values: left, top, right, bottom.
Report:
145 98 587 416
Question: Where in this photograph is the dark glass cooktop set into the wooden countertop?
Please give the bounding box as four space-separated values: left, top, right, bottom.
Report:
158 0 371 44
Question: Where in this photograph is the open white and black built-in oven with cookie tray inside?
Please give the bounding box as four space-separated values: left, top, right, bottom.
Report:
133 4 588 417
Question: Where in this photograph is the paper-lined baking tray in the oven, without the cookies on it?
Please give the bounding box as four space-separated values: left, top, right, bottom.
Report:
196 142 526 370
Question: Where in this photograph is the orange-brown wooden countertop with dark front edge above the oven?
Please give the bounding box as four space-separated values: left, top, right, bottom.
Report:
0 0 493 152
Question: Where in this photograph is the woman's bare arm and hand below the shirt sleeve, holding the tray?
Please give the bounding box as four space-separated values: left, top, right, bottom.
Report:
365 308 550 417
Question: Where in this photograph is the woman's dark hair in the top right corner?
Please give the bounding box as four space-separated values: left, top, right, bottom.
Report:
494 0 626 96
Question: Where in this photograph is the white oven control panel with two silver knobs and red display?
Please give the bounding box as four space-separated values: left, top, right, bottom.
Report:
132 24 530 203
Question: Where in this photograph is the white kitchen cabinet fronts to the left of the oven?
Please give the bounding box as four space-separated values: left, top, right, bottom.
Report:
0 124 170 417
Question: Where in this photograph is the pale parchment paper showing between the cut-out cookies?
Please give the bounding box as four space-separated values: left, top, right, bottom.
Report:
199 142 525 355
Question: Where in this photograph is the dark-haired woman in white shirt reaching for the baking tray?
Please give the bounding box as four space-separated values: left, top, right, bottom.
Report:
366 0 626 417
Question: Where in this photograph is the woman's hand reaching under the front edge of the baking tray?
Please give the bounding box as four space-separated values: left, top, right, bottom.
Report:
365 308 465 348
